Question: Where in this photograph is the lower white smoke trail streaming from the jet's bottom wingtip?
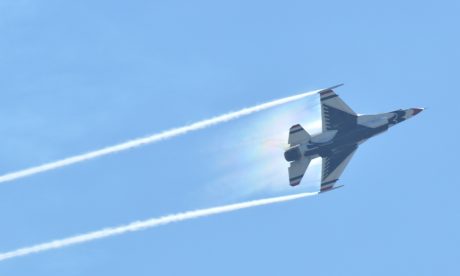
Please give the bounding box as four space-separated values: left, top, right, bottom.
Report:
0 193 318 261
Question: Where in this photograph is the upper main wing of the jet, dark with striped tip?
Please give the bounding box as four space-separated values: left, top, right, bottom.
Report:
319 88 358 133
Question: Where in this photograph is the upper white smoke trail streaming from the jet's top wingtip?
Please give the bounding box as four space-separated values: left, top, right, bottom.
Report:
0 90 319 183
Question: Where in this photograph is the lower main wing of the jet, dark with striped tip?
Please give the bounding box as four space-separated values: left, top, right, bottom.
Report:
321 145 358 192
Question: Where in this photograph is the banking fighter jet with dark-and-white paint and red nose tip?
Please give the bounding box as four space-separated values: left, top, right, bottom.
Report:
284 84 424 192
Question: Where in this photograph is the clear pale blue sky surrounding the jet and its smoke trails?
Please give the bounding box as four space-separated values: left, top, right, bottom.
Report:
0 0 460 276
